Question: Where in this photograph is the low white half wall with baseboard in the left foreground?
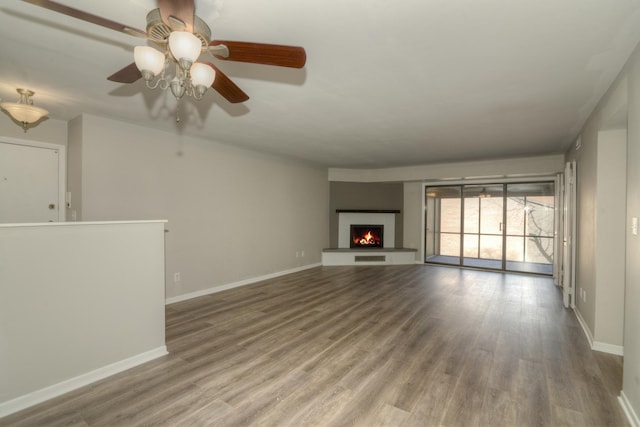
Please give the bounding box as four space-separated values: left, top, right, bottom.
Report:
0 222 166 417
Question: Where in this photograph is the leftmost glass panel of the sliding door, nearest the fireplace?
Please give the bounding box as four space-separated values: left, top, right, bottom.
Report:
425 186 462 265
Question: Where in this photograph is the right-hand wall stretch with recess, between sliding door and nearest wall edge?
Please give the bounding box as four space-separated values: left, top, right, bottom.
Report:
567 94 627 354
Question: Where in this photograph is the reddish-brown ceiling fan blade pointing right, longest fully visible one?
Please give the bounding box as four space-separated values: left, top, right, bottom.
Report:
209 40 307 68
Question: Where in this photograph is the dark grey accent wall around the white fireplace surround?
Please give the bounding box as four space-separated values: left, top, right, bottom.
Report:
329 181 404 248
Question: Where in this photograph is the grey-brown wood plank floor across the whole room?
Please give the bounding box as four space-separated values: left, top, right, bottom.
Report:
0 265 628 426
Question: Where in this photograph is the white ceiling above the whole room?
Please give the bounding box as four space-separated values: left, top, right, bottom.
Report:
0 0 640 168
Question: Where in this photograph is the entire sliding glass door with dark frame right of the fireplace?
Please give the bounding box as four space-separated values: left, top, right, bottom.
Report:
425 182 555 274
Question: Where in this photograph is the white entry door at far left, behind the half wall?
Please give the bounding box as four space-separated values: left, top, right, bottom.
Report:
0 142 62 223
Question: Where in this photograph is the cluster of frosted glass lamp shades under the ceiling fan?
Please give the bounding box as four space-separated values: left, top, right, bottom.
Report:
134 31 216 100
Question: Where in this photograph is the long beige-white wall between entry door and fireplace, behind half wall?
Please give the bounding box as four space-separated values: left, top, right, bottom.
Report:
69 115 329 297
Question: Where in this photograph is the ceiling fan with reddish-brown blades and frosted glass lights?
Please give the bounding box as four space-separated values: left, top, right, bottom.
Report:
23 0 306 103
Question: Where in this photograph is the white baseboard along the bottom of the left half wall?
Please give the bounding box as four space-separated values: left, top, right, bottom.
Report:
0 345 168 418
